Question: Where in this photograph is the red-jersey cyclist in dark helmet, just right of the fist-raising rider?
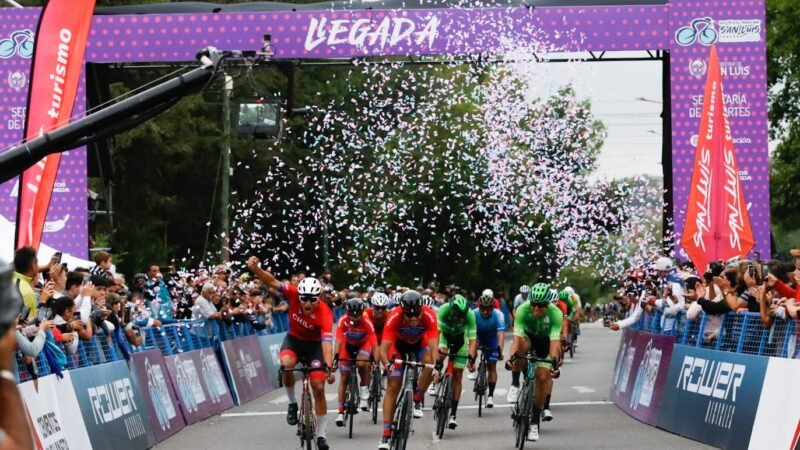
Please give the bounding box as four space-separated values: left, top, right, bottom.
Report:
334 298 378 427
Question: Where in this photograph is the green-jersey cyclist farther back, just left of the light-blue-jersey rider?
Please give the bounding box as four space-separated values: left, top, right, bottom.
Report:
436 294 478 430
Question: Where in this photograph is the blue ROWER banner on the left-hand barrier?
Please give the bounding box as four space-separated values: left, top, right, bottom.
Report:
71 361 156 450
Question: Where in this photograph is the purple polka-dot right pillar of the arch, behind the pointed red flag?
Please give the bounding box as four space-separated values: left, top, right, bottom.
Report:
669 0 770 259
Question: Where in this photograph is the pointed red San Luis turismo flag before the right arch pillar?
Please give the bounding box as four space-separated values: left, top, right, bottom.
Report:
681 46 755 273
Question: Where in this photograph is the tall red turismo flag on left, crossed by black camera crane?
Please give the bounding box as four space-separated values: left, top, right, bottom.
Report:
15 0 95 249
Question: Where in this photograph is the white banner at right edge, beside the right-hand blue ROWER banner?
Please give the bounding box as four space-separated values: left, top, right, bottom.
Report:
749 358 800 450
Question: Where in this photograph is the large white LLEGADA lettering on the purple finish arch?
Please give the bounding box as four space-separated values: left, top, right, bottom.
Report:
305 17 439 51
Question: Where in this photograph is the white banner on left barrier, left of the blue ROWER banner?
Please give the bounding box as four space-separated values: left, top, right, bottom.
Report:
18 371 92 450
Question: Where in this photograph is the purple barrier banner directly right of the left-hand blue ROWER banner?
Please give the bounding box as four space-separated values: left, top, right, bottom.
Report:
131 349 186 442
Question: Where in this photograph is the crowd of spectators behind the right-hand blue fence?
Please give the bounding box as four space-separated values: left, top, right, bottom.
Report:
603 250 800 358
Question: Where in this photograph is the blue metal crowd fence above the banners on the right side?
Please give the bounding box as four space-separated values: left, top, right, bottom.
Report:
633 310 798 358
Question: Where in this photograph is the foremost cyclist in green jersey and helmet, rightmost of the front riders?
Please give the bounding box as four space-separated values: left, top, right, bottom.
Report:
506 283 564 441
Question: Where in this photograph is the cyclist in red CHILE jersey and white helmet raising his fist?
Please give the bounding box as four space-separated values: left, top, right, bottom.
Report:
247 256 336 450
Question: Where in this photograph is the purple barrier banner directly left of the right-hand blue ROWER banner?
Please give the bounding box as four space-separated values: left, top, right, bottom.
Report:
611 328 675 425
